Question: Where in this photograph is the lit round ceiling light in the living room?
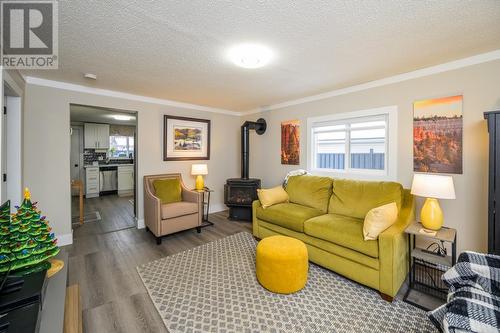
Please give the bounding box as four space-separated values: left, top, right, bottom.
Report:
228 43 273 68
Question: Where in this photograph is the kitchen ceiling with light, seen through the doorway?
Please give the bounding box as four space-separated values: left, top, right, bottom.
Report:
69 104 136 126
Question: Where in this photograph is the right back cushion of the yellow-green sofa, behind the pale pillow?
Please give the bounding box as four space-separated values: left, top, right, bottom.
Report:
328 179 403 219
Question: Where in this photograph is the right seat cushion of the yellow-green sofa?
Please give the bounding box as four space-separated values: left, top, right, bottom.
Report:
304 214 378 258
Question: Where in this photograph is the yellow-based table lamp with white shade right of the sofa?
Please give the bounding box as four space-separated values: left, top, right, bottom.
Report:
411 173 455 230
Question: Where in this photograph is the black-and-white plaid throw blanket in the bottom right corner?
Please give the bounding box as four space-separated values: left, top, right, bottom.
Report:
429 251 500 333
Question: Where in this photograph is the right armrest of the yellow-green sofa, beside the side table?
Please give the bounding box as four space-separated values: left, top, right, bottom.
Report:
378 189 415 297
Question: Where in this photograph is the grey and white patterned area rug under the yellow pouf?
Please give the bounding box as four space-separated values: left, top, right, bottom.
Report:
137 232 436 333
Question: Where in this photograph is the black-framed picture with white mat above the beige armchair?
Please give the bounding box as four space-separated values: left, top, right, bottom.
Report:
163 115 210 161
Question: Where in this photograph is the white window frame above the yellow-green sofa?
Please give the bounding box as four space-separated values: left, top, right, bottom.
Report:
307 105 398 181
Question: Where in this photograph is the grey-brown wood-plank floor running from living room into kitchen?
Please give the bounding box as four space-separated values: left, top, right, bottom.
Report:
63 197 251 333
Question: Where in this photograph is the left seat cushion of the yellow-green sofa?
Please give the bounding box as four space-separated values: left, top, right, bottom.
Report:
257 203 323 232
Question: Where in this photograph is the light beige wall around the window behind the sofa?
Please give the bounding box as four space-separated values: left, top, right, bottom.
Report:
247 61 500 251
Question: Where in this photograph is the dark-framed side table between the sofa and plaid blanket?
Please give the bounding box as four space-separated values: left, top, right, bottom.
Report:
403 221 457 310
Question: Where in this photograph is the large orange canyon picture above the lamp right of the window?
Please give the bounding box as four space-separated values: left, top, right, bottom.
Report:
413 96 463 174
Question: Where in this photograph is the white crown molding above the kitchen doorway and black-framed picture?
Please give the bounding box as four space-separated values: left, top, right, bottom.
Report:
25 76 243 117
